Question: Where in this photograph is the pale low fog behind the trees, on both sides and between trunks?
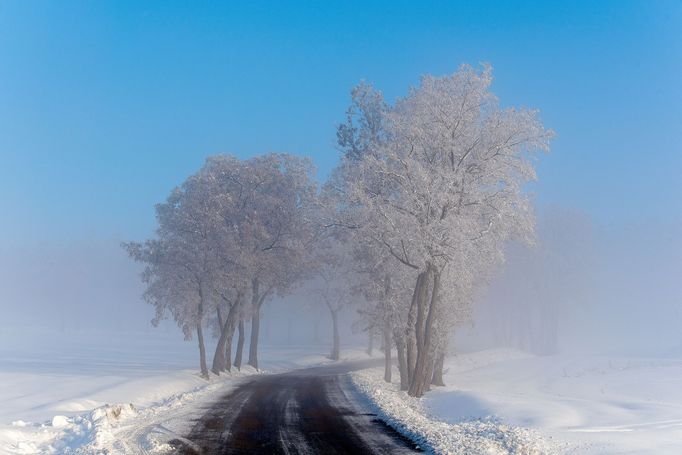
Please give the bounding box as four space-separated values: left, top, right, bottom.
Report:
0 205 682 356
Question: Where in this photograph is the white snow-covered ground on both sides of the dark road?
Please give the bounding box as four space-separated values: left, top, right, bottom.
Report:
5 332 682 454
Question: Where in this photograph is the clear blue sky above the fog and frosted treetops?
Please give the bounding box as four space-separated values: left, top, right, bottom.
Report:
0 0 682 252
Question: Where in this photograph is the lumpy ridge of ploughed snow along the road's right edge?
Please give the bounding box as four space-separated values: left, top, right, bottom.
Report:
351 368 553 455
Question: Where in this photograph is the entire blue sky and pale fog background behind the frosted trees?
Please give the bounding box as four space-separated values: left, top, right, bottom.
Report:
0 2 682 362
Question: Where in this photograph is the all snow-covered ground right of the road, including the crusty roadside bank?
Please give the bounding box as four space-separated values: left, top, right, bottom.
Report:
354 349 682 454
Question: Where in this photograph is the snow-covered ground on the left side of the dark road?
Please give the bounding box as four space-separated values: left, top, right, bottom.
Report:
0 333 365 454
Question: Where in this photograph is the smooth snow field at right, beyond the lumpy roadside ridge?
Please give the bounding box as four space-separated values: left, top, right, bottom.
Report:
423 350 682 454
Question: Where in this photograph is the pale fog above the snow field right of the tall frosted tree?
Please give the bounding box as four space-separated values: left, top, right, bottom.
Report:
458 206 682 355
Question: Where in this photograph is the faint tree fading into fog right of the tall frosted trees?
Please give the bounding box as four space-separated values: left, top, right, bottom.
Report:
479 207 595 355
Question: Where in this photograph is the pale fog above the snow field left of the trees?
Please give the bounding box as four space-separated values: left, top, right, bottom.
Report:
0 239 151 332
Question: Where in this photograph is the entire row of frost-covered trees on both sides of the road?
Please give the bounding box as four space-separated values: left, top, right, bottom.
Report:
124 66 552 396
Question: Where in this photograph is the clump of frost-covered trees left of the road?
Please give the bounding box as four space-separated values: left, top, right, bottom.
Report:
124 154 316 375
